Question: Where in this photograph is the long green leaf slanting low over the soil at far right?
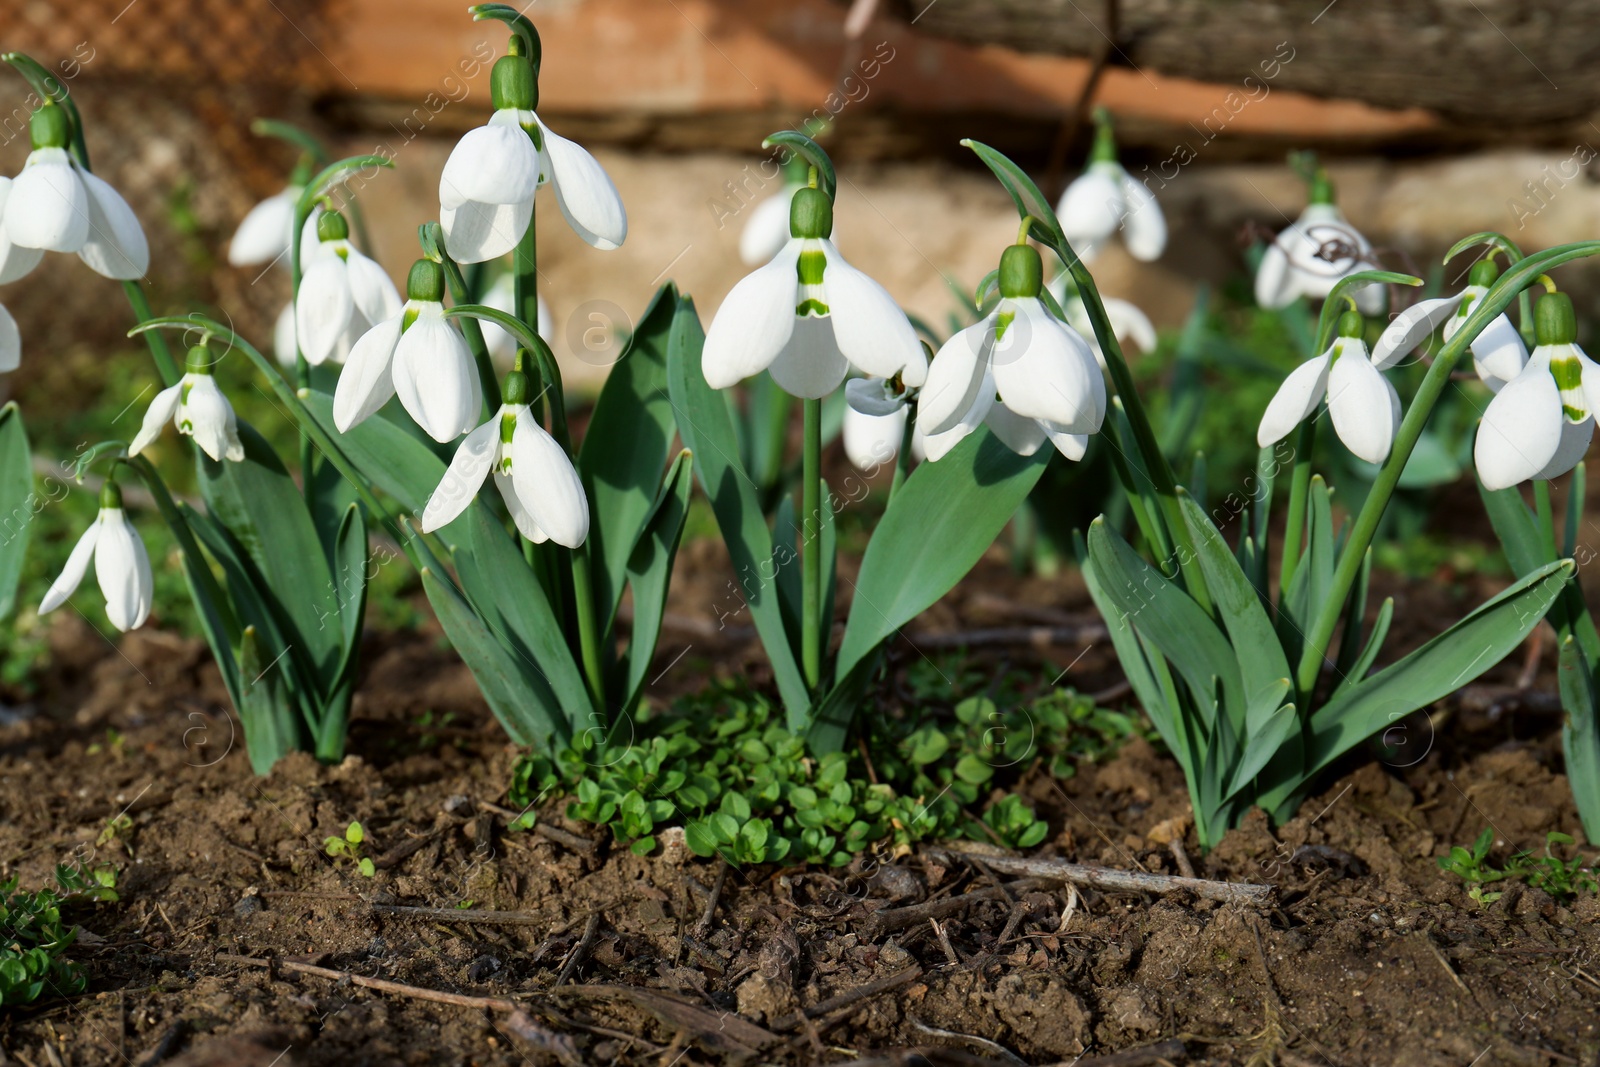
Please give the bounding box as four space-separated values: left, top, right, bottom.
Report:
1261 560 1578 809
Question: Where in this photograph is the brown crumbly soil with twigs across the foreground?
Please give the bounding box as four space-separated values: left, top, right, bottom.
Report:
0 545 1600 1067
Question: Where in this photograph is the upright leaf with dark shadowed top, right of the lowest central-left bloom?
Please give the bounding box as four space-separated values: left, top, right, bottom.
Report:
578 283 678 629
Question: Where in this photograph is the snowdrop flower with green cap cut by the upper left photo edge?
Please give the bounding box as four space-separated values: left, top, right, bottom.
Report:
0 99 150 282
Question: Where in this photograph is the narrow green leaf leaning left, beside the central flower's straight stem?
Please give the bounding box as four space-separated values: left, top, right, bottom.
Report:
667 298 811 728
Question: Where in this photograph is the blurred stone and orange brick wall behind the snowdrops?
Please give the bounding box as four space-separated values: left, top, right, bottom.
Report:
0 0 1600 387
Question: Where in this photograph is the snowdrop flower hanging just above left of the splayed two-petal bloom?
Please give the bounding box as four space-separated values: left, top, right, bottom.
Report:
333 259 483 442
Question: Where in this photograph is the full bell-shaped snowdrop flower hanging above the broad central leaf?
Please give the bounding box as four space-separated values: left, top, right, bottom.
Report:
917 245 1106 461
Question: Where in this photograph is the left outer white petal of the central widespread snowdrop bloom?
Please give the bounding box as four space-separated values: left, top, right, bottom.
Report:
701 238 802 389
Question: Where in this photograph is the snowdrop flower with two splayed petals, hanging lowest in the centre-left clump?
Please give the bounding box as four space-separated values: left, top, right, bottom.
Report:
422 370 589 549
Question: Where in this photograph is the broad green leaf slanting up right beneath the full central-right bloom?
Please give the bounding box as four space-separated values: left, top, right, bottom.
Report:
834 427 1051 680
